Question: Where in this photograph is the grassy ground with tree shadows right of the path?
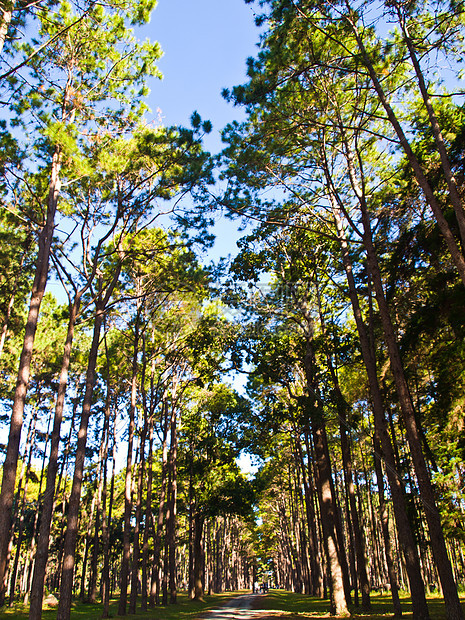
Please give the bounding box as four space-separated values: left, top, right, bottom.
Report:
250 590 465 620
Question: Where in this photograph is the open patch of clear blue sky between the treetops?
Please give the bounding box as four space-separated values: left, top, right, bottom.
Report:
143 0 259 151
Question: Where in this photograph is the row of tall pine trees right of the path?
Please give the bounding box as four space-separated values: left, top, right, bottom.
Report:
218 0 465 618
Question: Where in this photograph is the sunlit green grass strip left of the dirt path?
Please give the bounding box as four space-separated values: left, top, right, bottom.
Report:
0 592 245 620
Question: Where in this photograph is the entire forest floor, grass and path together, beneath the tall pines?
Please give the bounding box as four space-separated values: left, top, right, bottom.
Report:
0 590 465 620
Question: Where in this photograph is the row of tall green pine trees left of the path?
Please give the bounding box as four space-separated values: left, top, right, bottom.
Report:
0 1 253 619
